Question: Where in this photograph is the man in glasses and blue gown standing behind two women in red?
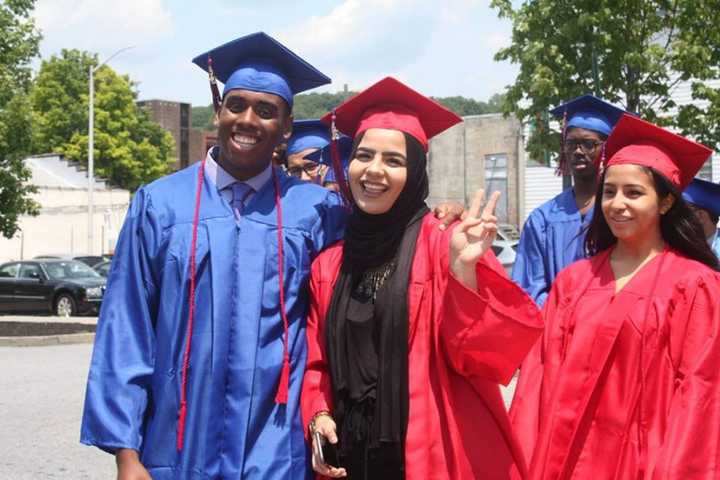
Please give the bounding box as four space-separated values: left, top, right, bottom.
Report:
512 95 624 307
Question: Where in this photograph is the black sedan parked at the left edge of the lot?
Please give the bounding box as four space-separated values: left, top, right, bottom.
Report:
0 260 106 316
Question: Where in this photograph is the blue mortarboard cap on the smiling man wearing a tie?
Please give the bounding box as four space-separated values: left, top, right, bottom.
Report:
193 32 330 107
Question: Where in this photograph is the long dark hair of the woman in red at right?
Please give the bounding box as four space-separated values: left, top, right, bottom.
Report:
585 165 720 271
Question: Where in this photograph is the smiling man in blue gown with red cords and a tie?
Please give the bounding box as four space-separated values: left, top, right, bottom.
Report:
81 33 346 480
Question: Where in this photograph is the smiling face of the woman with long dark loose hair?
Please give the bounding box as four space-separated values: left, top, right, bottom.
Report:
602 165 674 243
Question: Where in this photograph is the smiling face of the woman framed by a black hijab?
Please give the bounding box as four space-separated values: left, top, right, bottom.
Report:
348 128 407 215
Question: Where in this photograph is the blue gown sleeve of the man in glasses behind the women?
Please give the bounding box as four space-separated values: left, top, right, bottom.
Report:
512 214 551 308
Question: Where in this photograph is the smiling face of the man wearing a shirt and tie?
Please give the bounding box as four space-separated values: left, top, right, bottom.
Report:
215 90 292 180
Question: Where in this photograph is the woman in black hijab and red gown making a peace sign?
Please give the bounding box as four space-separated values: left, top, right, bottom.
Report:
302 78 542 480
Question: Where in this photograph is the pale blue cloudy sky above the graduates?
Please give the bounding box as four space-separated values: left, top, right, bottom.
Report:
35 0 517 105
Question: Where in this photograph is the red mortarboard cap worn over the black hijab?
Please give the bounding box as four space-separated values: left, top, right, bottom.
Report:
322 77 462 151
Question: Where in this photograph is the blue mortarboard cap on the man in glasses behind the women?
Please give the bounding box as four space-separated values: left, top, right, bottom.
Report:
550 95 627 135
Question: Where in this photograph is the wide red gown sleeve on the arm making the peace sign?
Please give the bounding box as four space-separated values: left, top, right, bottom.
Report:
440 229 542 385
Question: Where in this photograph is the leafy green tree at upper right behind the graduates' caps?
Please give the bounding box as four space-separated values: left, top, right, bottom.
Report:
491 0 720 158
